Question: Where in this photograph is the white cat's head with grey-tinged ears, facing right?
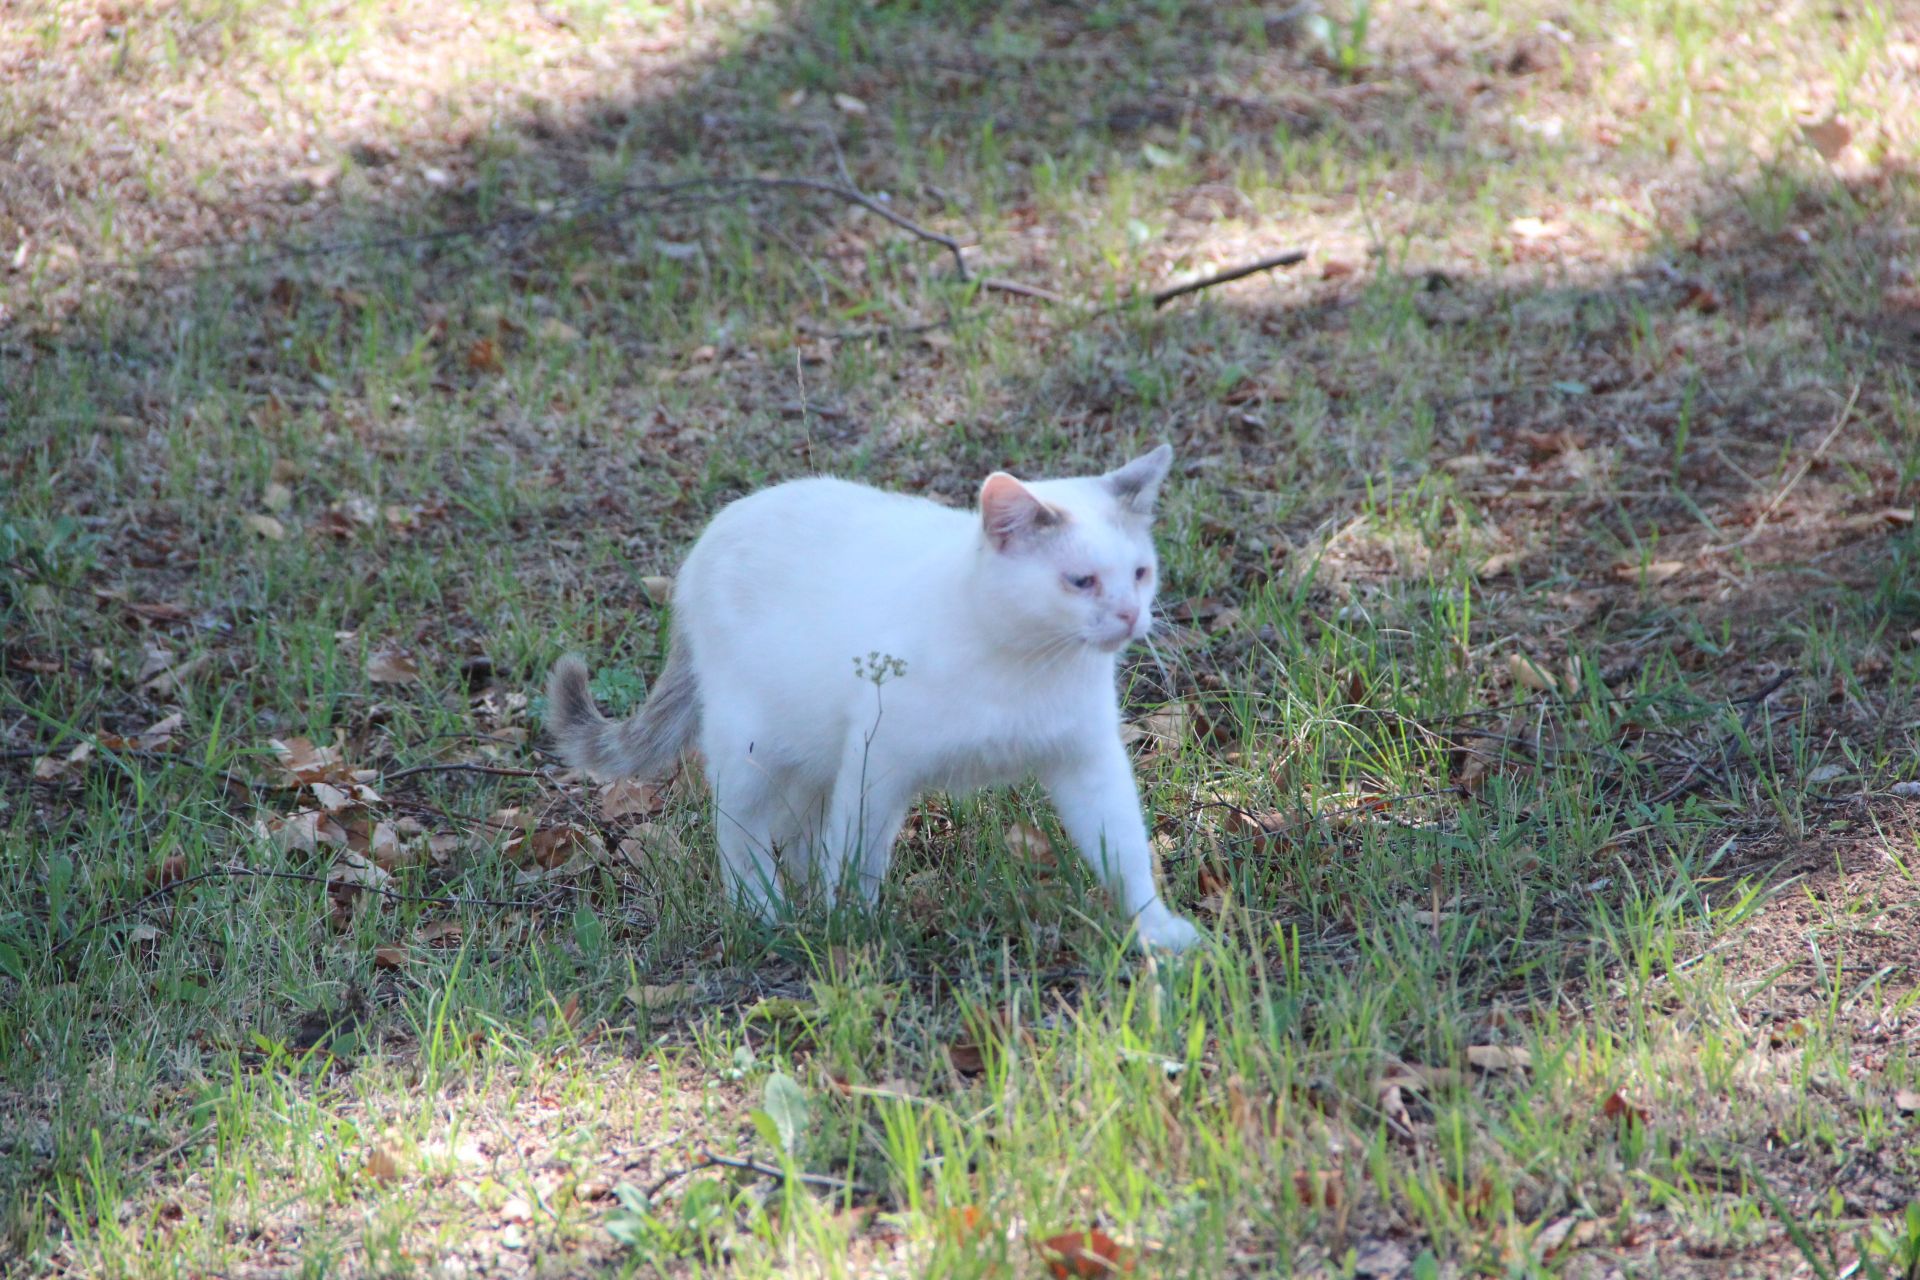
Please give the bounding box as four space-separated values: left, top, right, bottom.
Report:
979 445 1173 652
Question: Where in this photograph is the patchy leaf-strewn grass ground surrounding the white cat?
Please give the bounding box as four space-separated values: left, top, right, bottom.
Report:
0 0 1920 1280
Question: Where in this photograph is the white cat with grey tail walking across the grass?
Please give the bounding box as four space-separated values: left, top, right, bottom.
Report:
547 445 1198 950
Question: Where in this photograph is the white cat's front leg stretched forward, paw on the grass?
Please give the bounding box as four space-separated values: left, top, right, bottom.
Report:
1043 737 1200 952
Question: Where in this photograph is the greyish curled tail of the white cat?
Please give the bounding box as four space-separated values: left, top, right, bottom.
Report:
547 643 701 781
